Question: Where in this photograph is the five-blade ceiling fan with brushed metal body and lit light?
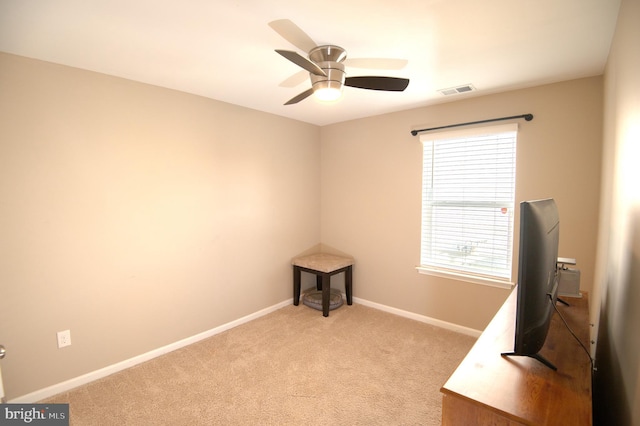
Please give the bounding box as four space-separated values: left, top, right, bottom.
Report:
269 19 409 105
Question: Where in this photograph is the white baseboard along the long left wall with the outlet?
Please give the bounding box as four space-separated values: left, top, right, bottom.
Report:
8 299 291 404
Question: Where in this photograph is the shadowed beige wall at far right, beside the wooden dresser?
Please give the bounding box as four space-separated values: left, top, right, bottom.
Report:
592 0 640 425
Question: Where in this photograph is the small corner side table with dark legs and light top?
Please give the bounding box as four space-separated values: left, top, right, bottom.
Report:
291 253 354 317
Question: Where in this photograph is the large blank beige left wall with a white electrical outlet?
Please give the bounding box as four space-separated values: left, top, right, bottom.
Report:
0 53 320 399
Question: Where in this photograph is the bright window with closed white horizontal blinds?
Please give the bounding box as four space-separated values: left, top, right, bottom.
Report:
418 124 517 286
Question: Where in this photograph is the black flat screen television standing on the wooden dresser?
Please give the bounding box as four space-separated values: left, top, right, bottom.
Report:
502 199 560 370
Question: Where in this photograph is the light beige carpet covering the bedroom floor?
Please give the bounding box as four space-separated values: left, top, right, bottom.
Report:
45 304 475 426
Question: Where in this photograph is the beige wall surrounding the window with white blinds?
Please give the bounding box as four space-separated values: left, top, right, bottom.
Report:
321 77 602 330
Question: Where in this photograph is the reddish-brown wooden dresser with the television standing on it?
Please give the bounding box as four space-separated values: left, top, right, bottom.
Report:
440 289 592 426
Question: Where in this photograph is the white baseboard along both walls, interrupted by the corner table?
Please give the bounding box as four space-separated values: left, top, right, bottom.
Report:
13 297 482 404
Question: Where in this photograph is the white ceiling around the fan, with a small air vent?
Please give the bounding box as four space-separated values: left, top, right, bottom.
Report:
0 0 620 125
